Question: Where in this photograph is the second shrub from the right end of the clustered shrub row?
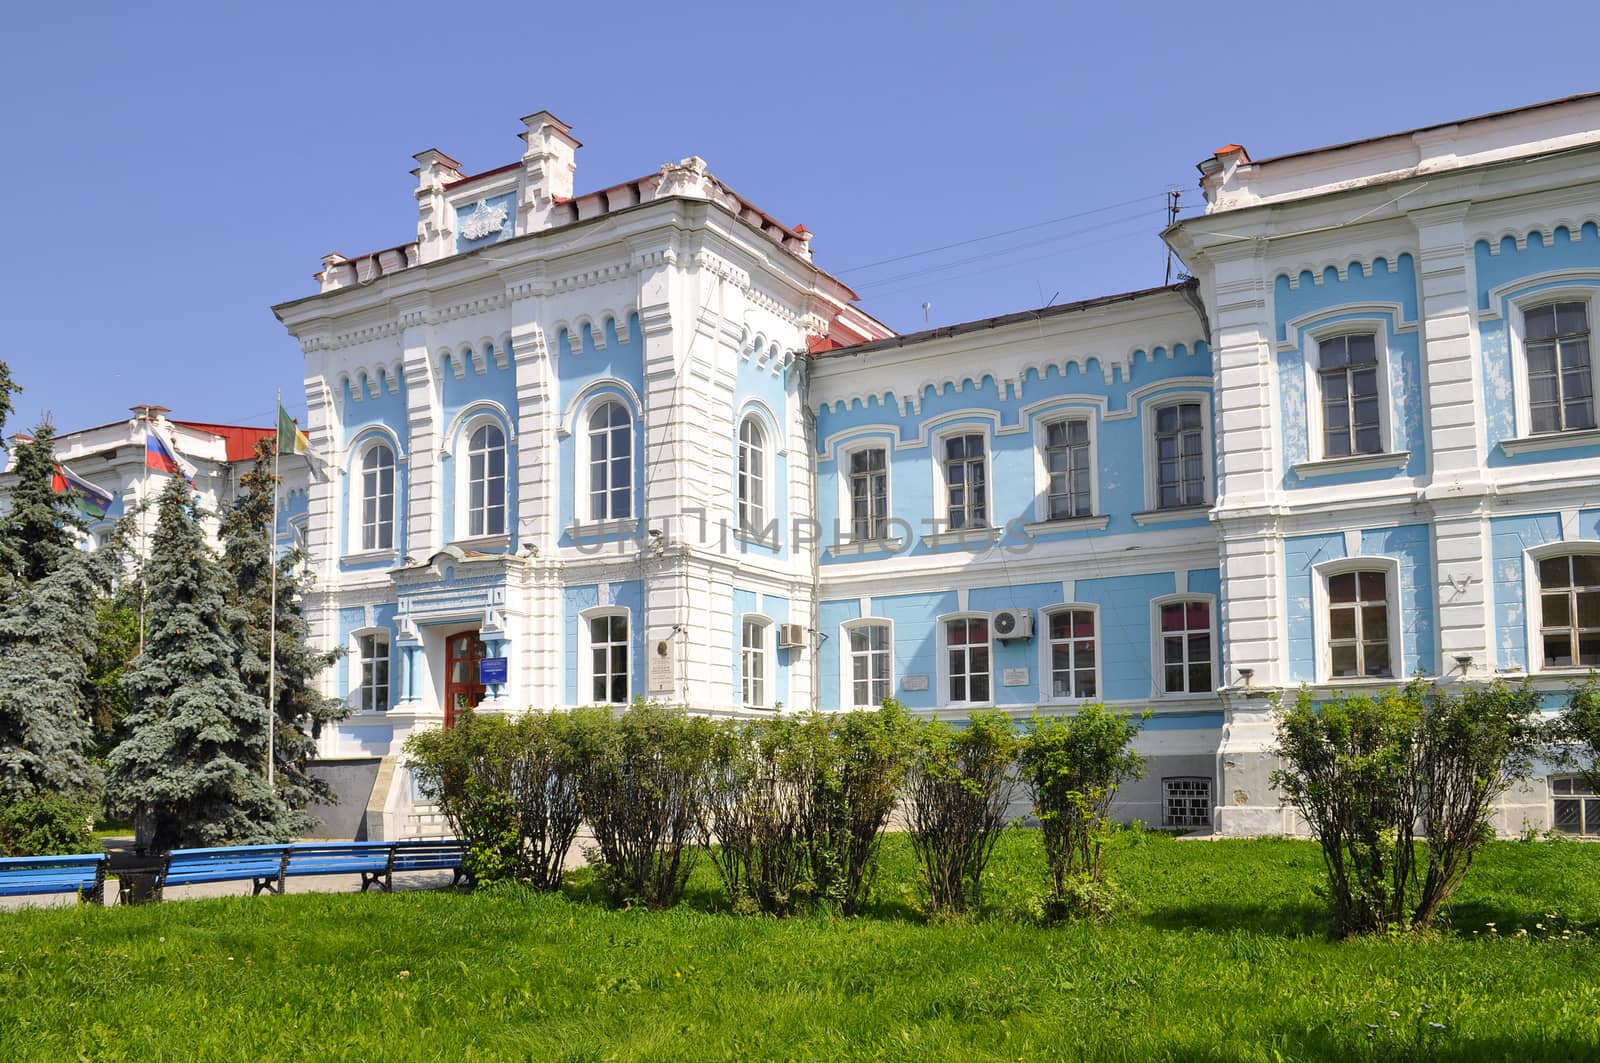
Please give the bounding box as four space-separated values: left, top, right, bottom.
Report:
906 712 1018 913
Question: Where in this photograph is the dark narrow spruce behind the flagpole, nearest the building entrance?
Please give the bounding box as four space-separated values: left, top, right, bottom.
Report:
221 437 349 832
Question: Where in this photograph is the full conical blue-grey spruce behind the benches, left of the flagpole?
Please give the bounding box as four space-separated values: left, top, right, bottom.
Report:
107 477 290 850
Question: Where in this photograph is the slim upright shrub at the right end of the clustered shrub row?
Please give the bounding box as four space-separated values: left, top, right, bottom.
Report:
1018 704 1144 919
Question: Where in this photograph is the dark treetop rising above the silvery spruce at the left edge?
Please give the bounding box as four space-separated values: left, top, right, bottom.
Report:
0 422 88 584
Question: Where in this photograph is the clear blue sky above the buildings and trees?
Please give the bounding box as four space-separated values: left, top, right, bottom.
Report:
0 0 1600 429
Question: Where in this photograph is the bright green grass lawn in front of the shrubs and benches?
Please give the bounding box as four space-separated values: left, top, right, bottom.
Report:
0 832 1600 1063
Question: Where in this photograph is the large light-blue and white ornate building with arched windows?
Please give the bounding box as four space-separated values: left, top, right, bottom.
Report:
275 94 1600 834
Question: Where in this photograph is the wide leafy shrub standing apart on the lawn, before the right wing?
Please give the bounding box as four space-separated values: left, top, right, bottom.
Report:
1272 682 1539 937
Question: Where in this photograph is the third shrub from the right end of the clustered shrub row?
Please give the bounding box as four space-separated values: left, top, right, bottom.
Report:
794 700 915 916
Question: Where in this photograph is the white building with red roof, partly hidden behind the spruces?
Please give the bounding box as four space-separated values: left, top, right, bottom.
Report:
0 403 310 551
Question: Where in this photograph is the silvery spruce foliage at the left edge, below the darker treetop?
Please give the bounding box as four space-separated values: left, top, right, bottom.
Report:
0 551 110 804
